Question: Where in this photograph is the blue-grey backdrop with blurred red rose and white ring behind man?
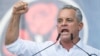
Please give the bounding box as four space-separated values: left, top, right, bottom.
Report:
0 0 100 56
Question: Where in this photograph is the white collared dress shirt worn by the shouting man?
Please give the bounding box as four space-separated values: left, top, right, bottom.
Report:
6 39 100 56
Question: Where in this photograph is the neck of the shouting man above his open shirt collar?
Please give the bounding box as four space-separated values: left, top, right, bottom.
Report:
60 38 80 51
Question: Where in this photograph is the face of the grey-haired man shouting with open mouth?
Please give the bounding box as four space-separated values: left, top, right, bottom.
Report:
57 9 83 40
